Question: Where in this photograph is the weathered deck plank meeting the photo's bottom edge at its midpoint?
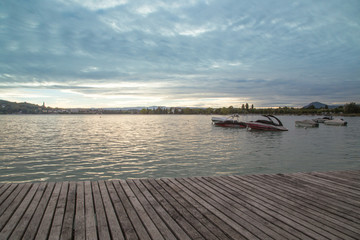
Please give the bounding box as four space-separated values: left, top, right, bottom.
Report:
133 180 190 240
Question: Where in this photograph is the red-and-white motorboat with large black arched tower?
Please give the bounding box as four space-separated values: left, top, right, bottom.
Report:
246 115 288 131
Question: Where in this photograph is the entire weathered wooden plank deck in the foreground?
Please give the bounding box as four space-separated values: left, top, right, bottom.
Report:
0 171 360 240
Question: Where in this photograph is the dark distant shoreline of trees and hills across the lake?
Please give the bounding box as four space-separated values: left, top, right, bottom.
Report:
0 100 360 116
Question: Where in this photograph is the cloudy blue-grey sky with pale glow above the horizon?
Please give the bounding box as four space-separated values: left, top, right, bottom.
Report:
0 0 360 107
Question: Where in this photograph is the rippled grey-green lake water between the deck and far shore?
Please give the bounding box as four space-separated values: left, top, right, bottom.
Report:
0 115 360 183
